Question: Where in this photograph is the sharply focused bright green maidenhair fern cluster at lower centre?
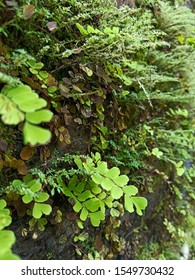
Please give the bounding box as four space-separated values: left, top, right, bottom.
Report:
61 152 147 227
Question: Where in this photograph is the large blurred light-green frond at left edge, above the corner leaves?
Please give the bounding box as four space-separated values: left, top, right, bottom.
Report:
0 75 53 145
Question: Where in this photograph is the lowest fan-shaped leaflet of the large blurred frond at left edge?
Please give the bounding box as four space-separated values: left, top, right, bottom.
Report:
23 122 51 145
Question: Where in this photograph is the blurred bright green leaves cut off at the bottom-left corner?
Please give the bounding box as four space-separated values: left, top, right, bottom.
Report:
0 199 19 260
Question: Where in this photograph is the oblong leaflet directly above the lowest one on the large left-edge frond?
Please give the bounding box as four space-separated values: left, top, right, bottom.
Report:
26 109 53 124
